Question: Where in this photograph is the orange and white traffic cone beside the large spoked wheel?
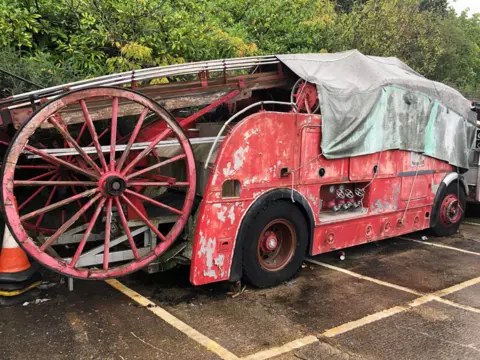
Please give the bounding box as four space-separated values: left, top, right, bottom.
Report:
0 226 41 306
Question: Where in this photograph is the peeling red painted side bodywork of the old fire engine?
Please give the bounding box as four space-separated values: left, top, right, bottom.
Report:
190 112 452 285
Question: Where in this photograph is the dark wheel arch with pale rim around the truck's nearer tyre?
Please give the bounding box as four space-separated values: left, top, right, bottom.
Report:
229 188 315 281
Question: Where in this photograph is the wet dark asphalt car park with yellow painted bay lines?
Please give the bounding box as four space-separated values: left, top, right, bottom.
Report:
0 215 480 360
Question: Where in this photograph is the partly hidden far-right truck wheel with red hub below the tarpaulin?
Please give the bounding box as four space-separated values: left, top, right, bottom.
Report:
430 182 467 236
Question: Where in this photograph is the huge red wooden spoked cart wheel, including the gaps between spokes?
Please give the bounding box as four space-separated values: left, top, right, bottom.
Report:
2 87 196 279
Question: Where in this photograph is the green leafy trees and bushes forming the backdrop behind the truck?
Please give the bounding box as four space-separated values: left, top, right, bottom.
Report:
0 0 480 97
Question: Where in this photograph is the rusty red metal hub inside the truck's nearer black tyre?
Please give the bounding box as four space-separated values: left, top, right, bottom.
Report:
257 219 297 271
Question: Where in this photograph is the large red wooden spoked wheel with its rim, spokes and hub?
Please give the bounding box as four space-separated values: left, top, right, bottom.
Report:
2 87 196 279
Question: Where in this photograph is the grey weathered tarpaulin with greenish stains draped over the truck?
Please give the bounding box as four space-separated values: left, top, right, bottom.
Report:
277 50 476 169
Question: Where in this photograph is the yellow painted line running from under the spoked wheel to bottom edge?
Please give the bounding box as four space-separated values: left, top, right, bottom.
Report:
105 280 239 360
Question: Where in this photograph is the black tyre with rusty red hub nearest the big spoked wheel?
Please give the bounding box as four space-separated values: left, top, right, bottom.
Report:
243 200 308 287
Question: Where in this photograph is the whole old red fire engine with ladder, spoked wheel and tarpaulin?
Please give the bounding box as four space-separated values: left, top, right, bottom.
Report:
0 51 476 287
